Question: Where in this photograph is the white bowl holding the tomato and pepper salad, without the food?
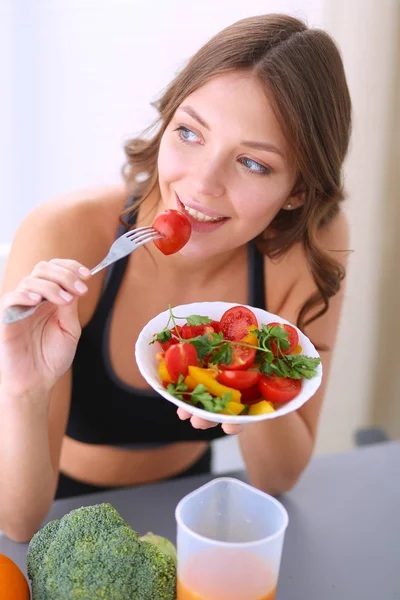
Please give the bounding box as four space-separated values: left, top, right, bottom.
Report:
135 302 322 423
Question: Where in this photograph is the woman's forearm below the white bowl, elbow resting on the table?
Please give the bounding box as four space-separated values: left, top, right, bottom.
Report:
239 412 314 494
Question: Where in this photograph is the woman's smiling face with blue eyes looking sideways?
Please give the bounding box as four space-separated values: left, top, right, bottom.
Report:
158 72 295 257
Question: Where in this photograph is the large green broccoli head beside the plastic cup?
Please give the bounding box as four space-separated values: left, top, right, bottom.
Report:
27 504 176 600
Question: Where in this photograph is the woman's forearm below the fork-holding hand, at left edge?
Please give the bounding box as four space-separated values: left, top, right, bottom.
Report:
0 386 55 541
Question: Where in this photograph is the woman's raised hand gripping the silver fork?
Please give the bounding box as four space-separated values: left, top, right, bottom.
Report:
0 259 91 394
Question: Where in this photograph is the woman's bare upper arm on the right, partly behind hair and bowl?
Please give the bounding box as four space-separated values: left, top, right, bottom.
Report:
271 213 349 439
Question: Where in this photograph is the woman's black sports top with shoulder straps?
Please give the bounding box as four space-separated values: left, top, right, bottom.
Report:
66 199 265 448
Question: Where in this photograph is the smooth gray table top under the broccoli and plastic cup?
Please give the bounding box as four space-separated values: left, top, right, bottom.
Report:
0 442 400 600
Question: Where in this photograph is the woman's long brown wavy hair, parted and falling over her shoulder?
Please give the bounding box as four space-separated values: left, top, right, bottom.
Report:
121 14 351 329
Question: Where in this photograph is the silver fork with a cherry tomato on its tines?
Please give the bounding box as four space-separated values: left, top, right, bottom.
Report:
3 227 164 324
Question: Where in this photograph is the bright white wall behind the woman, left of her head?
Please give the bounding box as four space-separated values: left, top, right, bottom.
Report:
0 0 322 241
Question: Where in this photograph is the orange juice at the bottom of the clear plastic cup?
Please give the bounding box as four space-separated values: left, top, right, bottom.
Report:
177 548 276 600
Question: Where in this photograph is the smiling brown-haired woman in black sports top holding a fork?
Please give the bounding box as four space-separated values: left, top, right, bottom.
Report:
0 15 350 541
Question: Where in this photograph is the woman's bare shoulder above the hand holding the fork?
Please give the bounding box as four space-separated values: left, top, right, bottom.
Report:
2 186 127 324
